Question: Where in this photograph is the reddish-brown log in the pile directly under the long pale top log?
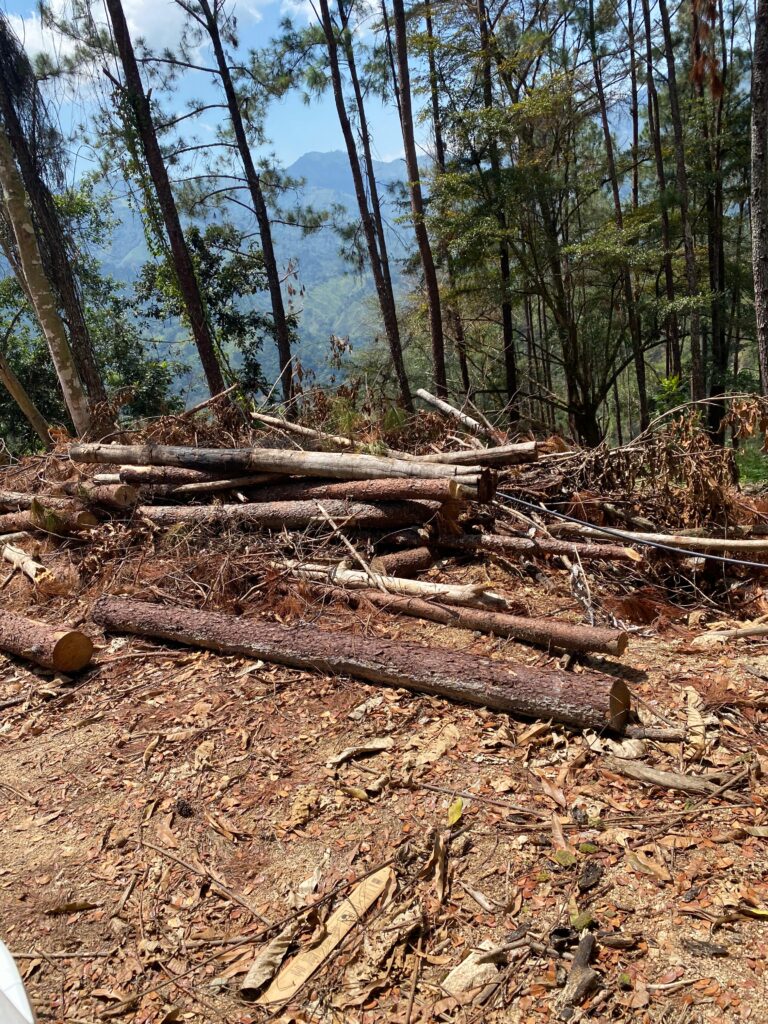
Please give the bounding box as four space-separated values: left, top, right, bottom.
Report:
244 470 496 502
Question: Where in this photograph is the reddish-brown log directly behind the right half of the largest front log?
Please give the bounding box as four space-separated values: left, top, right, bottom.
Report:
348 590 629 654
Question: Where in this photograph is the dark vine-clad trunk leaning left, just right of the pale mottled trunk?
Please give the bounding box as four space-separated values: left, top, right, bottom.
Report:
105 0 224 394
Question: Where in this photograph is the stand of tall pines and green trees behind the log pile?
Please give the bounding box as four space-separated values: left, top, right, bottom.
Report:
0 0 768 452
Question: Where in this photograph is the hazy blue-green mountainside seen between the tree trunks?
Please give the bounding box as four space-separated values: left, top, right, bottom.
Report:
99 151 406 389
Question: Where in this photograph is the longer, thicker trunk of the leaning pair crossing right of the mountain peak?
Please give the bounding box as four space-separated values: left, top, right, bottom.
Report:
318 0 414 412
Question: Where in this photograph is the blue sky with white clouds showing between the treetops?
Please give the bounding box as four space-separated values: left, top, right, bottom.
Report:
0 0 402 166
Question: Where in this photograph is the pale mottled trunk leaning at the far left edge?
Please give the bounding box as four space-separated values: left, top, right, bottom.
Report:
0 128 91 434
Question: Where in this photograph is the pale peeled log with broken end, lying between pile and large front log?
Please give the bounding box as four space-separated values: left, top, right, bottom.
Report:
286 560 507 608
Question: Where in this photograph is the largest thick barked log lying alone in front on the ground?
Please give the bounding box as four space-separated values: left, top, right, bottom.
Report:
92 597 630 731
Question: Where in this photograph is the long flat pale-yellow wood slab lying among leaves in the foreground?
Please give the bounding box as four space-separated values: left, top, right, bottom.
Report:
258 867 394 1006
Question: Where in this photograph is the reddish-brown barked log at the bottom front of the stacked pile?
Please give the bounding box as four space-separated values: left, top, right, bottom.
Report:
138 501 440 529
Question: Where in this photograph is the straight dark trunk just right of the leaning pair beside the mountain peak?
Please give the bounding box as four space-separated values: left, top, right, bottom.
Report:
392 0 447 398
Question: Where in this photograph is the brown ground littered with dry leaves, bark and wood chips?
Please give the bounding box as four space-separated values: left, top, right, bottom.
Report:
0 544 768 1024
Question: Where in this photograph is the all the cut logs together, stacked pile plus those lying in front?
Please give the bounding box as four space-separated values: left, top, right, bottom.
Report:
0 395 637 731
